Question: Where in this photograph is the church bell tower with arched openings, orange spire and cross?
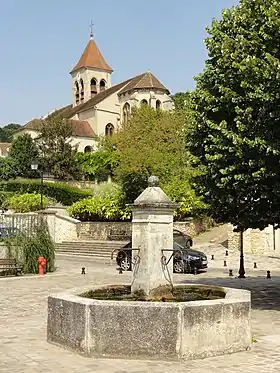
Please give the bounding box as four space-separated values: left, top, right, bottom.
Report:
70 26 113 106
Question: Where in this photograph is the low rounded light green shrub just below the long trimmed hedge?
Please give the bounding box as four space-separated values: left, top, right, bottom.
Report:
6 193 50 212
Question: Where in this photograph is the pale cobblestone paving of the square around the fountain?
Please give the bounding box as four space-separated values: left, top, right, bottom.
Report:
0 251 280 373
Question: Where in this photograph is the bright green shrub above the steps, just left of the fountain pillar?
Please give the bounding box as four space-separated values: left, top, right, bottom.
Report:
67 185 130 221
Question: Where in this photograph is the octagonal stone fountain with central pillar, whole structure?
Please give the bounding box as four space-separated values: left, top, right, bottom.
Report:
47 176 251 361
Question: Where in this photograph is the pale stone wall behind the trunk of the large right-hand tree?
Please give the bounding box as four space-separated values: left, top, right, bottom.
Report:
228 224 280 254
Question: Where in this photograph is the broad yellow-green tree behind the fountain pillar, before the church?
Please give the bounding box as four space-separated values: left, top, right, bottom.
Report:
112 106 206 219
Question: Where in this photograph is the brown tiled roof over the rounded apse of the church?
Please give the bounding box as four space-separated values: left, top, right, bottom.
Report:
119 72 170 95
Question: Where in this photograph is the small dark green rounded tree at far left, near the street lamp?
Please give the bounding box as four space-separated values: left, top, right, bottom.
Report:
8 134 38 177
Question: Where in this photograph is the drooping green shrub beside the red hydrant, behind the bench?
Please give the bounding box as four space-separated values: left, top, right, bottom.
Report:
4 221 55 274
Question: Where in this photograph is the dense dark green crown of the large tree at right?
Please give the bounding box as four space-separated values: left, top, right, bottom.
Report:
188 0 280 231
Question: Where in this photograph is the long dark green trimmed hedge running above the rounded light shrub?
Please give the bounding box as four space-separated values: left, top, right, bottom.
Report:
0 180 92 206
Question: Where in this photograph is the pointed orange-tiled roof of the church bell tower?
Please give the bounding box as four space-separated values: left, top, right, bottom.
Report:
71 39 113 73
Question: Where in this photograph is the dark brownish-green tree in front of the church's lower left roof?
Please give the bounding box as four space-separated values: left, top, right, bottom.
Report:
37 114 78 180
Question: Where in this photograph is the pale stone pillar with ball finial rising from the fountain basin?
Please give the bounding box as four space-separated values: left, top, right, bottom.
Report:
131 176 178 295
